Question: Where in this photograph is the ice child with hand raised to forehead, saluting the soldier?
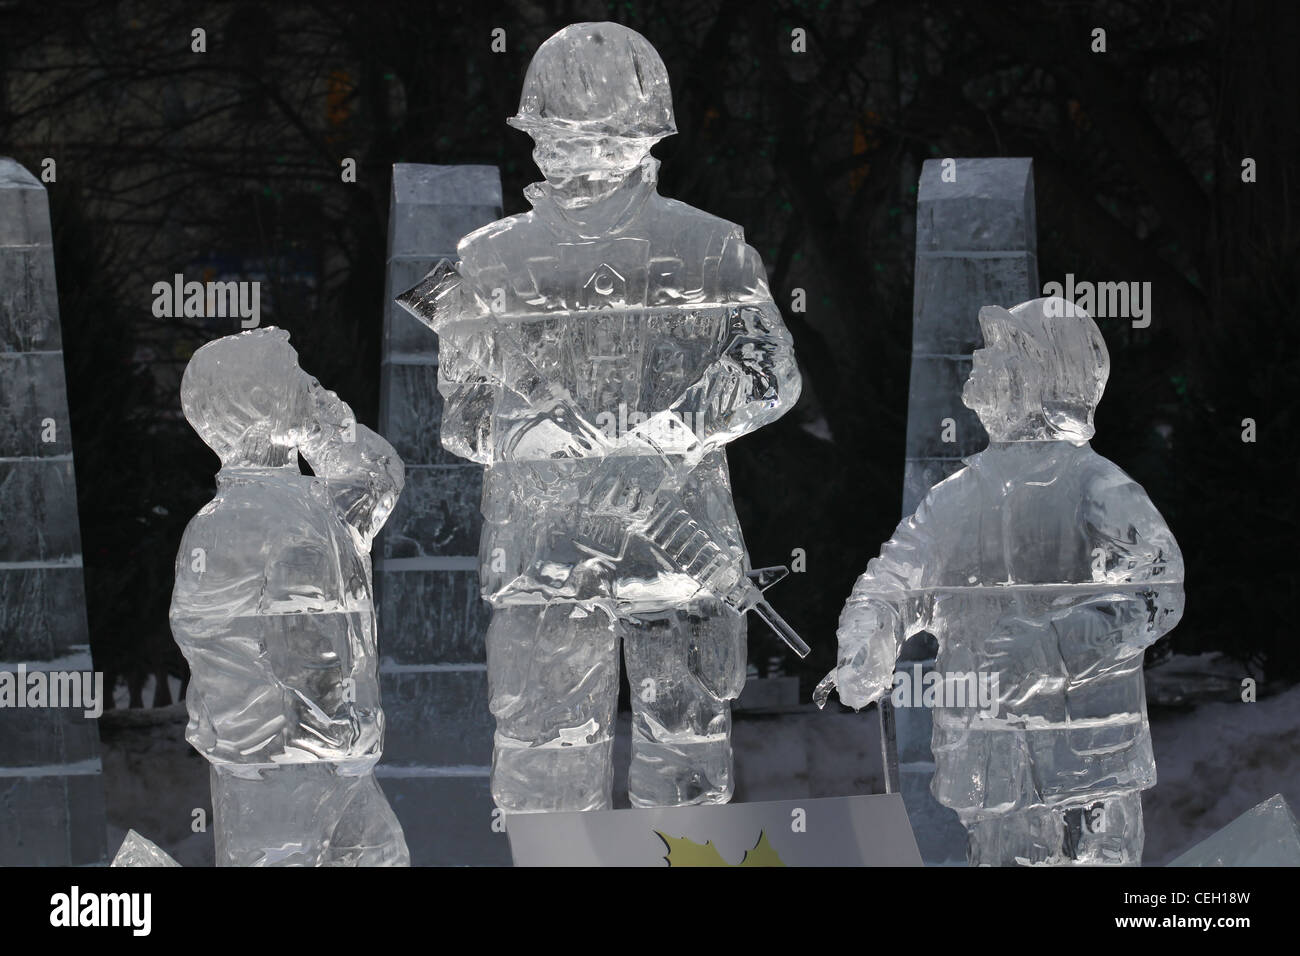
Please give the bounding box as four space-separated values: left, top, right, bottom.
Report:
172 328 410 866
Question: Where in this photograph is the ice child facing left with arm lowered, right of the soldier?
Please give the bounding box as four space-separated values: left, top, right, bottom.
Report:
816 298 1183 865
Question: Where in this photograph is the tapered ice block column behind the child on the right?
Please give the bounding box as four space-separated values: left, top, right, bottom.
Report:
899 159 1041 864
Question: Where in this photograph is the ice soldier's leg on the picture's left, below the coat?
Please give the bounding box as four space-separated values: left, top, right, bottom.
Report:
488 602 619 813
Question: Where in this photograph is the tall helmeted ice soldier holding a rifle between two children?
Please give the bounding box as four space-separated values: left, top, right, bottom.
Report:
399 23 807 812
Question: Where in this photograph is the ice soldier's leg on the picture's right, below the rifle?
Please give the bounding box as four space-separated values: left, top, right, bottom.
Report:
623 600 745 806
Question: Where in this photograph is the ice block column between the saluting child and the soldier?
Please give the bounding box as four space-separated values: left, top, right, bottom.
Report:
374 163 510 866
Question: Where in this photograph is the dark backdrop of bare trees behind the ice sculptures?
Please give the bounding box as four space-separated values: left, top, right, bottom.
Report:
0 0 1300 706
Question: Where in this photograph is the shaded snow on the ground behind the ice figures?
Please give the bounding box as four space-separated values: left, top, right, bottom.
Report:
101 662 1300 866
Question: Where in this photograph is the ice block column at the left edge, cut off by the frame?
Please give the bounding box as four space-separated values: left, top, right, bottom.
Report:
0 157 109 866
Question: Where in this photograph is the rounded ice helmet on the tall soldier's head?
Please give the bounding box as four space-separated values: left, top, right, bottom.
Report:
507 23 677 139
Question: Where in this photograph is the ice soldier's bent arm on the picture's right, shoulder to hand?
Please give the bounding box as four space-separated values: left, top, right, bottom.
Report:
670 232 802 451
